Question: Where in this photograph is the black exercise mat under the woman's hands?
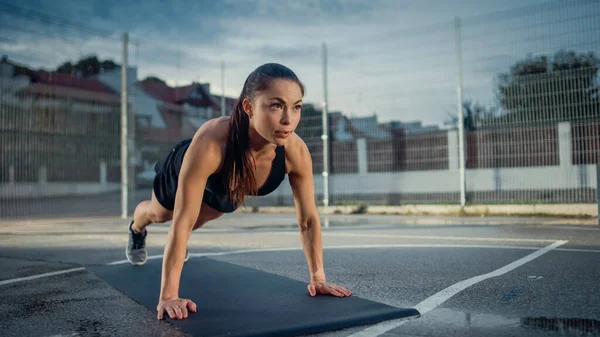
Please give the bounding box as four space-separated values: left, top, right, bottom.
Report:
88 258 419 337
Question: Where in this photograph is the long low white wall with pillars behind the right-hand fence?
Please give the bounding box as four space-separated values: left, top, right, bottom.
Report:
266 123 597 197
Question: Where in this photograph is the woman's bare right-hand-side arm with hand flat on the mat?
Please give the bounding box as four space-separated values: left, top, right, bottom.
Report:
286 138 351 296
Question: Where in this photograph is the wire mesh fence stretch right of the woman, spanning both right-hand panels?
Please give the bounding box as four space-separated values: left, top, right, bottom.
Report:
250 1 600 209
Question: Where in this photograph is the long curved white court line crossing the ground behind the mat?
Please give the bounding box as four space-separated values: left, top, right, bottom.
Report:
0 244 600 286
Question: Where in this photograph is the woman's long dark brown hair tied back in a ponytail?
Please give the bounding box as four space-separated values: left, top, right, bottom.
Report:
223 63 304 205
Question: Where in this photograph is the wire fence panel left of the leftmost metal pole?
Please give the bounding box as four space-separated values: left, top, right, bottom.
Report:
0 4 135 218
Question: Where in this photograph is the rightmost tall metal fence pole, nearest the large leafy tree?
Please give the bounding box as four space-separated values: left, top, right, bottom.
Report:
455 16 466 207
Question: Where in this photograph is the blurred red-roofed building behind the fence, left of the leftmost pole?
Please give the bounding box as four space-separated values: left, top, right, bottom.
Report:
0 57 121 183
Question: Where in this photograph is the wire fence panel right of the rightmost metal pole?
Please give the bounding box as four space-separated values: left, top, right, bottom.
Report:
461 1 600 203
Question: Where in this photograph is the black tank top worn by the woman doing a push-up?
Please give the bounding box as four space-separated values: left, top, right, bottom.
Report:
177 139 285 213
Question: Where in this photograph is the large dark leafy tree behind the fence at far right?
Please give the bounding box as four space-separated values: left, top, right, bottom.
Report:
495 50 600 124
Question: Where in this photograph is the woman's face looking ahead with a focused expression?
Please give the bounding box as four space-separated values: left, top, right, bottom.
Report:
243 79 302 145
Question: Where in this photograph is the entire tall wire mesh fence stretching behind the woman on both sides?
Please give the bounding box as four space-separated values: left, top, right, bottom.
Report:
0 0 600 219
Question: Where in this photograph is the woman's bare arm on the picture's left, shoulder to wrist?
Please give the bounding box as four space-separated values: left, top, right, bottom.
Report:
159 129 221 301
